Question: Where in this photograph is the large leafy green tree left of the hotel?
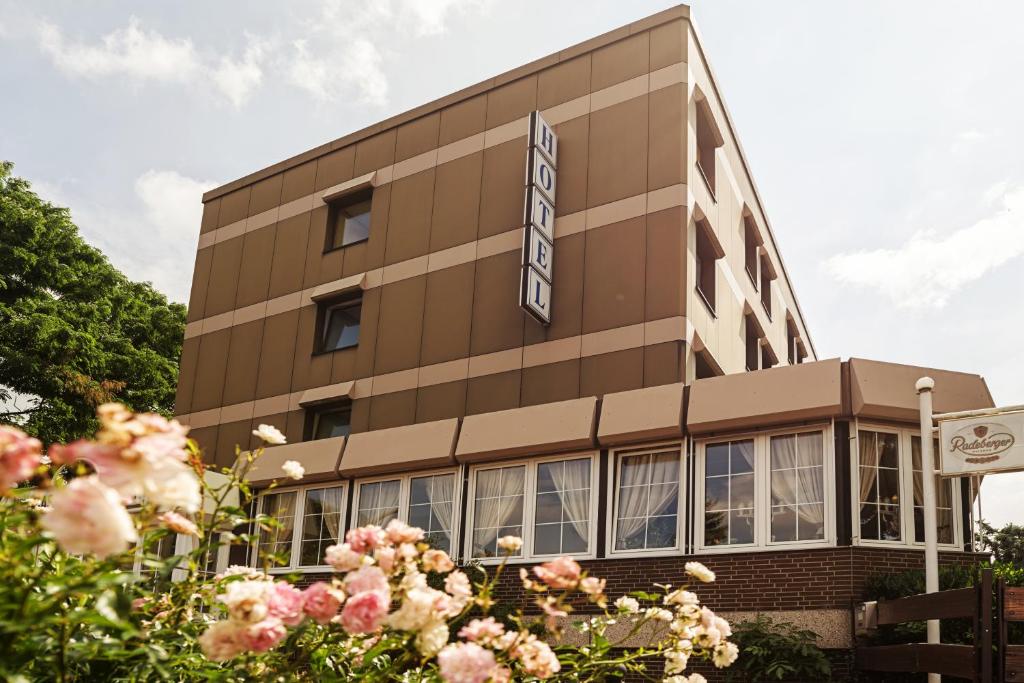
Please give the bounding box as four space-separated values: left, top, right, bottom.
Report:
0 162 185 443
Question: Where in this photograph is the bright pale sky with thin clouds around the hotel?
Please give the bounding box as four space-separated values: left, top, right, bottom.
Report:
0 0 1024 523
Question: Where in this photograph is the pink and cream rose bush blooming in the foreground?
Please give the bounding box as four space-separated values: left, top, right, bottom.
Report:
0 404 737 683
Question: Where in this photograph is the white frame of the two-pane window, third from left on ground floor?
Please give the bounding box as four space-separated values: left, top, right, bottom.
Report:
463 451 601 564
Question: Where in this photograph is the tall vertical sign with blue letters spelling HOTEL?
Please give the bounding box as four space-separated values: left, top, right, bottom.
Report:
519 112 558 325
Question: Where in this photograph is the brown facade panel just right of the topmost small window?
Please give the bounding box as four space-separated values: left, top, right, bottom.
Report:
382 169 434 265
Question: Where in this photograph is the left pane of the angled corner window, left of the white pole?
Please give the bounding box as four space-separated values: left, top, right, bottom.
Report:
857 429 903 541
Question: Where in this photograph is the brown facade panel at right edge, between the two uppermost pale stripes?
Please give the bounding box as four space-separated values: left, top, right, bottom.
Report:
647 83 686 190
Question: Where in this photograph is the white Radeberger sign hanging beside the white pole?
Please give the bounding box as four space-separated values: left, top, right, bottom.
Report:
939 411 1024 476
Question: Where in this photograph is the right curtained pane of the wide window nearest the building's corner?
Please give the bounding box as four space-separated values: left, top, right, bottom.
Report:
770 432 825 543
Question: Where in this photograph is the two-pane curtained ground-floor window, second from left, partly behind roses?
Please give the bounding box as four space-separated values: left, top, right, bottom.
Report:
354 470 459 553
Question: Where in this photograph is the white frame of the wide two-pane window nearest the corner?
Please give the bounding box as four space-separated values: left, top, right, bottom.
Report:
693 422 836 555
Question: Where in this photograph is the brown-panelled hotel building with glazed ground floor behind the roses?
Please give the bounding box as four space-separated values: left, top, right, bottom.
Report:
176 6 992 671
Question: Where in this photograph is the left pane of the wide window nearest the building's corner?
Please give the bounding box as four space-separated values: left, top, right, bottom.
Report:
705 439 755 546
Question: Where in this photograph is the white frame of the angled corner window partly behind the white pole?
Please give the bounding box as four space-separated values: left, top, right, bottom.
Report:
850 420 964 552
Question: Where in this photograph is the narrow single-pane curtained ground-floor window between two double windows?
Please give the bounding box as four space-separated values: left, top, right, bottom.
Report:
611 445 682 554
